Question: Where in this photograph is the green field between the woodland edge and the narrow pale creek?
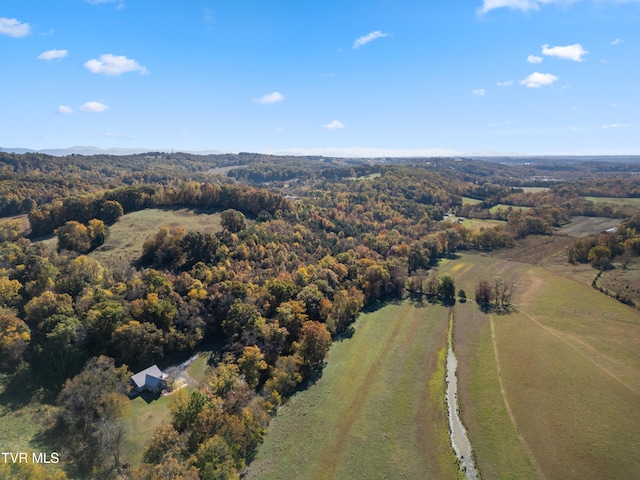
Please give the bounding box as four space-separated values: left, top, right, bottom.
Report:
248 302 459 479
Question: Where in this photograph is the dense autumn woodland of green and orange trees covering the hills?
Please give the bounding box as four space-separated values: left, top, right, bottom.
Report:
0 153 640 479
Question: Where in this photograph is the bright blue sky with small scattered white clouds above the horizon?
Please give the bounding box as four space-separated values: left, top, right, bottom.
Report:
0 0 640 156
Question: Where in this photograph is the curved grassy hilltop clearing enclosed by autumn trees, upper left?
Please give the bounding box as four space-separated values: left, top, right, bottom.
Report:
90 208 222 269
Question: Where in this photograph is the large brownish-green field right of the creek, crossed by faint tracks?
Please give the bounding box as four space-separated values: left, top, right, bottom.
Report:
440 251 640 479
